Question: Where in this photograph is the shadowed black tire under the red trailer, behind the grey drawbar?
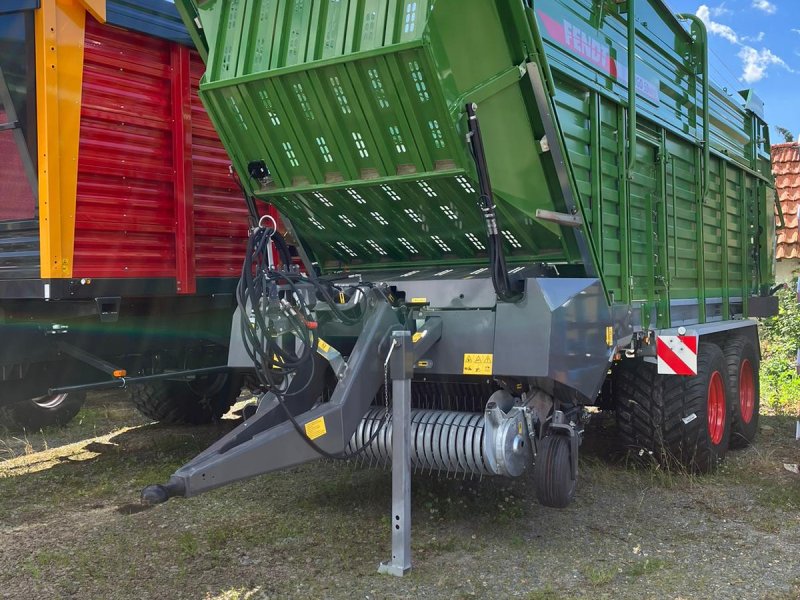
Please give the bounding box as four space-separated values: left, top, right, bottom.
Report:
128 373 241 425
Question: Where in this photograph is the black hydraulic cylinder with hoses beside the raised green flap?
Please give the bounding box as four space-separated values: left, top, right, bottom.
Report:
467 103 521 302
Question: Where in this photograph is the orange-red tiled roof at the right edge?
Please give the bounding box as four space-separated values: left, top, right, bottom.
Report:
772 142 800 259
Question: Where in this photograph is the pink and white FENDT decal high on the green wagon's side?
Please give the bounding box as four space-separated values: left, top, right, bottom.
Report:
538 10 659 103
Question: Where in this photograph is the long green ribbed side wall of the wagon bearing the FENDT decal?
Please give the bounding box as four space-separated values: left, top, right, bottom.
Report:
534 0 772 327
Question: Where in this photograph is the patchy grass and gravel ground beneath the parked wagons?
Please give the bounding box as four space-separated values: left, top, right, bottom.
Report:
0 393 800 600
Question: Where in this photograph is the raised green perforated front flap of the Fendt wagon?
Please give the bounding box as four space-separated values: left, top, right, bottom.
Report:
182 0 579 268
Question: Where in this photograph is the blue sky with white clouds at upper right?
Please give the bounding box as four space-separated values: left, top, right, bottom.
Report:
665 0 800 143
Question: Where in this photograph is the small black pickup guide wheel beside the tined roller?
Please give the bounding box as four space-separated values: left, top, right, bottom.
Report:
533 435 577 508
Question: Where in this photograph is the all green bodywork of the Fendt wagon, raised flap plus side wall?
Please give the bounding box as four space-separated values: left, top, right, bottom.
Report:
178 0 772 327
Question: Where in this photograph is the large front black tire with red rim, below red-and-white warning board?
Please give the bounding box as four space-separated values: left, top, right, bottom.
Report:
614 342 731 473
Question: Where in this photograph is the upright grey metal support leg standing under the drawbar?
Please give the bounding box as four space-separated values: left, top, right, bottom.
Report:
378 331 414 577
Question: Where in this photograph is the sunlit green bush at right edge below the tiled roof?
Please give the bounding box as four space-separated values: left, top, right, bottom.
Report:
760 280 800 415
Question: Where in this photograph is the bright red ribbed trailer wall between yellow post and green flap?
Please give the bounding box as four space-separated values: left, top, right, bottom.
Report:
73 19 247 293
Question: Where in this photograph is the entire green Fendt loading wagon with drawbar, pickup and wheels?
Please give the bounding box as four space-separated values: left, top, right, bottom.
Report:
144 0 777 573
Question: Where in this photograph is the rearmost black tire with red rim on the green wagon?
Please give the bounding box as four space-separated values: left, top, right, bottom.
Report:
724 335 761 448
